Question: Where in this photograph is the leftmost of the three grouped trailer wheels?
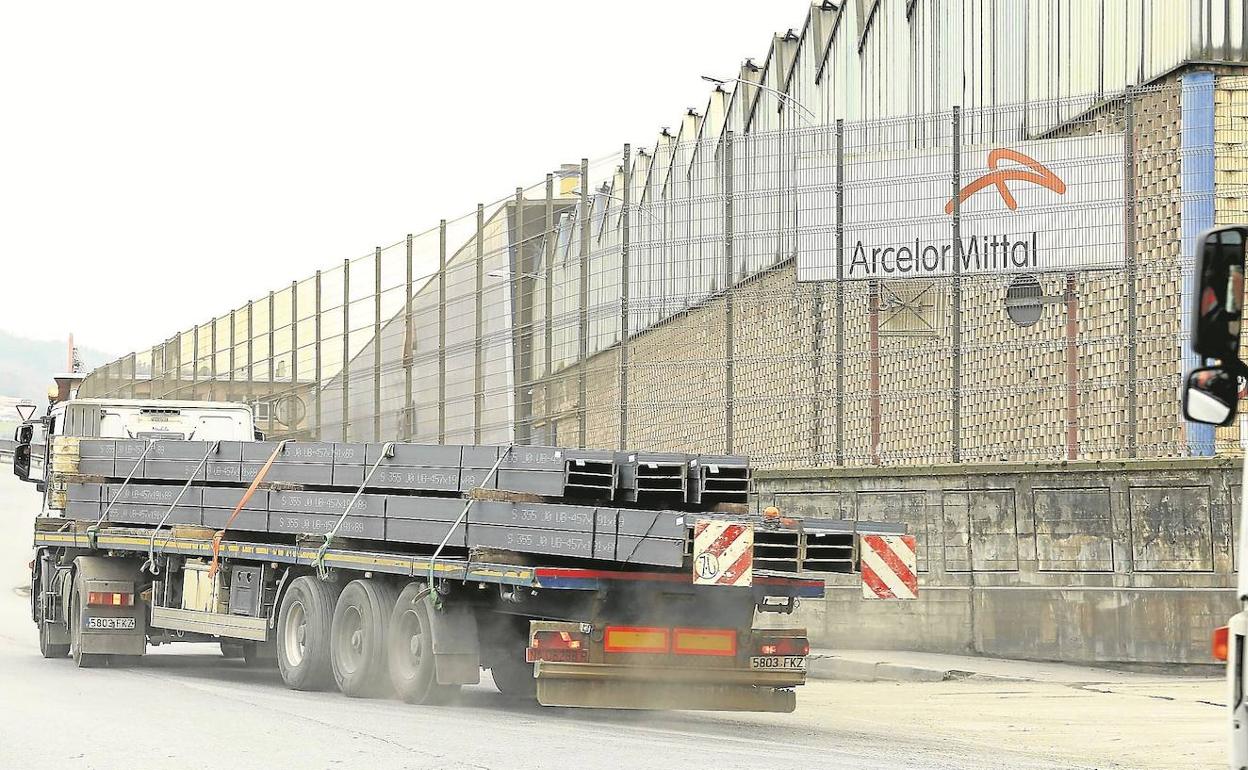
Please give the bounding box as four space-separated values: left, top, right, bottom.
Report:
277 575 341 690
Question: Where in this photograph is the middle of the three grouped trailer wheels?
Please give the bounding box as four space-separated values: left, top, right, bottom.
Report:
329 580 396 698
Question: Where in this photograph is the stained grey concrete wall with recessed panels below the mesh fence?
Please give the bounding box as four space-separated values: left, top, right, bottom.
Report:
758 458 1243 664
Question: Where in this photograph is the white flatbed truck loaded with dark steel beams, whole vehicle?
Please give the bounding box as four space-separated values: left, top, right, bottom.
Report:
15 402 904 711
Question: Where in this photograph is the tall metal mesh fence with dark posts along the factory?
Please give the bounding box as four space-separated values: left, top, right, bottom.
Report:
80 74 1248 467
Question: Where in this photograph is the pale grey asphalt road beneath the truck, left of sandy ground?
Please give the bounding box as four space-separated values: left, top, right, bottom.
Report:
0 469 1093 770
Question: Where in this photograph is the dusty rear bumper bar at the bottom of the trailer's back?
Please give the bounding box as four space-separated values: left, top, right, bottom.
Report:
533 660 806 713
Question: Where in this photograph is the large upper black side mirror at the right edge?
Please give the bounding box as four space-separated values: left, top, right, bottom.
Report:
1192 227 1248 361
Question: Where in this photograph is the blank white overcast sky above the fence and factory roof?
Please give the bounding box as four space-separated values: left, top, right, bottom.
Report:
0 0 809 354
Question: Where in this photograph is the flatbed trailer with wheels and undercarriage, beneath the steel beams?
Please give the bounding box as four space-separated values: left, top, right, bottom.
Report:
31 518 824 711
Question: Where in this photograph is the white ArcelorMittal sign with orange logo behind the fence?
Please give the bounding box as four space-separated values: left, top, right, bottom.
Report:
797 134 1126 281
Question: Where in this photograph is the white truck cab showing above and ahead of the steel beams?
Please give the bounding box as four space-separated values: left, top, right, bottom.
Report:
12 398 262 514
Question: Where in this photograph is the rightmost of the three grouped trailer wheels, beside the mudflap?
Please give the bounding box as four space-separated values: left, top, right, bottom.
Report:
386 583 459 705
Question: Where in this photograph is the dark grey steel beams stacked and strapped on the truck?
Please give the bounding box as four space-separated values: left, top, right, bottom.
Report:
65 439 888 572
